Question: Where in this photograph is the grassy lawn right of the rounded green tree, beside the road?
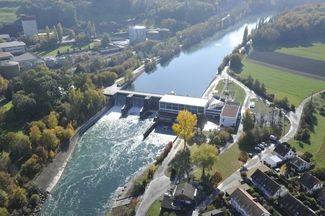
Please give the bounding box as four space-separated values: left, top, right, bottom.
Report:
193 144 242 179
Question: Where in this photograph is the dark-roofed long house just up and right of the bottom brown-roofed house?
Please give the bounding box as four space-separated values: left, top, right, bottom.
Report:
251 169 286 199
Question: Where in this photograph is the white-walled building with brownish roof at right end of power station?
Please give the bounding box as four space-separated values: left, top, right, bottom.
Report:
219 101 241 127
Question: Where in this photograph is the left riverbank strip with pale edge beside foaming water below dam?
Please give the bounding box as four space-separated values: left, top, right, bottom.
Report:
34 104 112 193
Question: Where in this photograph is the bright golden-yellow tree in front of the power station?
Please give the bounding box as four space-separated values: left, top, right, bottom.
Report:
172 110 197 149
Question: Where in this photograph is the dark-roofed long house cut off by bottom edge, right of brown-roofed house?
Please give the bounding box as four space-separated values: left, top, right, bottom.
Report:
279 193 316 216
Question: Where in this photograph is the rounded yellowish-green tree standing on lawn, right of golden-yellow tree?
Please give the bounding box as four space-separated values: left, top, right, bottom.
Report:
191 144 218 177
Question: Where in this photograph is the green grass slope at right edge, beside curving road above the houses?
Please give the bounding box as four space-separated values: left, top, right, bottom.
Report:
289 98 325 167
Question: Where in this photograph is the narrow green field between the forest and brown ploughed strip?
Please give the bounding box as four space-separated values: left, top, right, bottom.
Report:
276 43 325 61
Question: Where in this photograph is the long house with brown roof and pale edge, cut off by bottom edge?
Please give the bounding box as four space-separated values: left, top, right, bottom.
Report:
230 188 271 216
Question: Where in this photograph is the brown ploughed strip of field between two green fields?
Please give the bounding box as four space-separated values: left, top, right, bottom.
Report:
249 50 325 79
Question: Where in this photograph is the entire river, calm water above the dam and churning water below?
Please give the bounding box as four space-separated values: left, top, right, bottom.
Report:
42 16 257 216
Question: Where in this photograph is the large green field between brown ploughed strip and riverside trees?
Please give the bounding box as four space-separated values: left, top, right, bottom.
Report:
239 59 325 106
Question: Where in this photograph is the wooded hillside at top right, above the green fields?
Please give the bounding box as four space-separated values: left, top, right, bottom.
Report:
253 4 325 48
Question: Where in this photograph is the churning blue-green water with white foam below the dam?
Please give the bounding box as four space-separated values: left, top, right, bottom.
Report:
42 107 174 215
